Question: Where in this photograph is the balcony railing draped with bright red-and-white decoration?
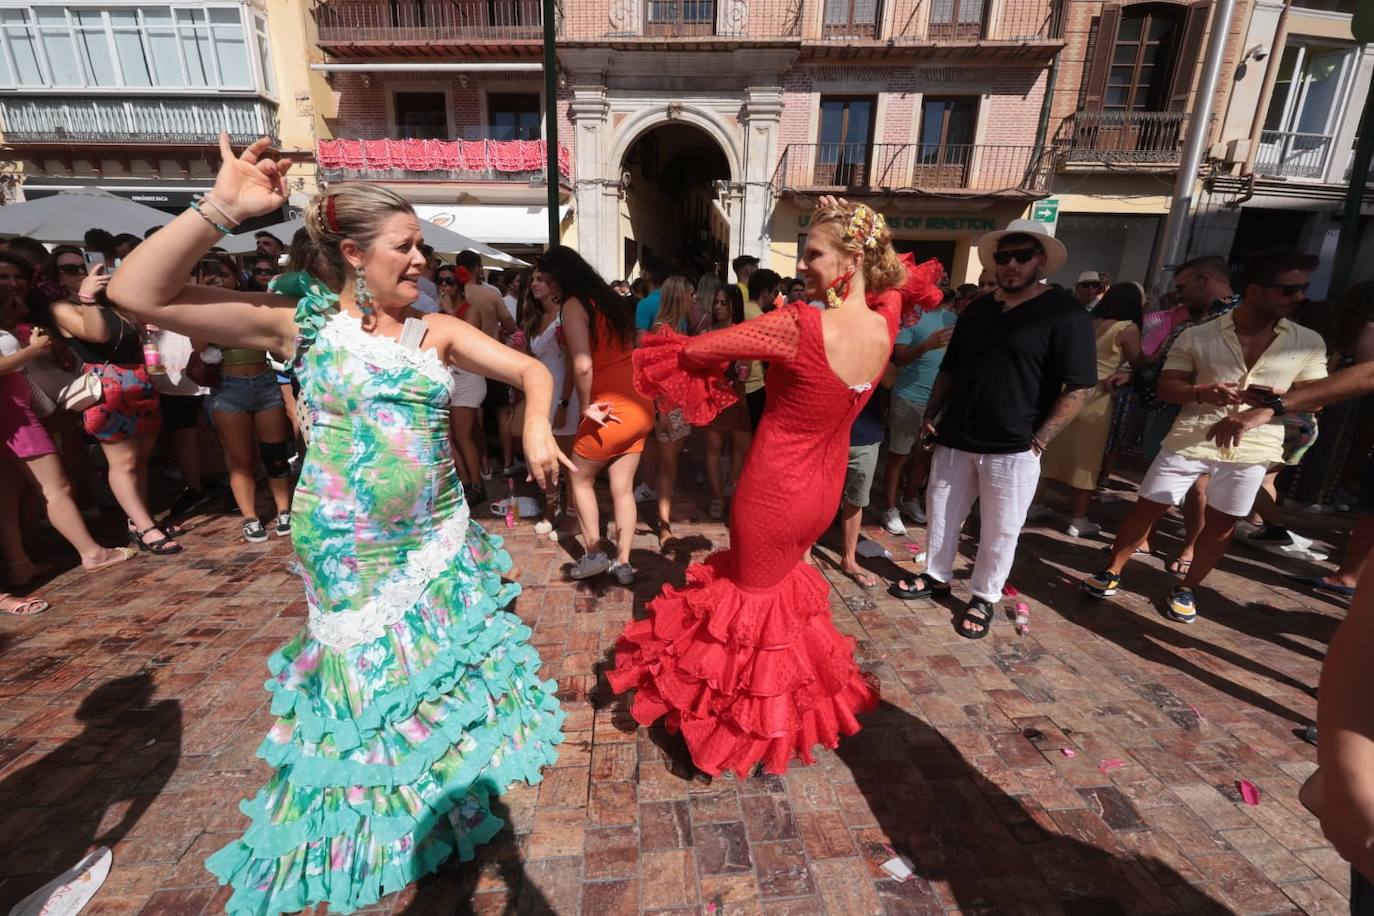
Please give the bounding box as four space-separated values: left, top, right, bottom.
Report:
316 126 572 185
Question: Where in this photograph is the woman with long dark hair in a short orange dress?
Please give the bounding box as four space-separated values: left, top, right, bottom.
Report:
534 244 654 585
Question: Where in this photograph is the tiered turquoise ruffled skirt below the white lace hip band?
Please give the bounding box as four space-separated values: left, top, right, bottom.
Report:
206 525 565 916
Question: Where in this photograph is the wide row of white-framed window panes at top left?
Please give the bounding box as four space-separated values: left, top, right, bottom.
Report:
0 4 275 95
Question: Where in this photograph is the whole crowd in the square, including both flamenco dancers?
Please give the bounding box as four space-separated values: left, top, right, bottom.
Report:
0 130 1374 912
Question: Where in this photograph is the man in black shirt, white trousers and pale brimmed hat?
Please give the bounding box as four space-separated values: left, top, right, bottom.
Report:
889 220 1098 639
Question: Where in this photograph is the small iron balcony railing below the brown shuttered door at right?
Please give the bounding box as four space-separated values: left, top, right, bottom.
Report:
1054 111 1187 170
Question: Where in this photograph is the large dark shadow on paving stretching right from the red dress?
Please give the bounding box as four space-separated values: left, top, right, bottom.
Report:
837 702 1231 916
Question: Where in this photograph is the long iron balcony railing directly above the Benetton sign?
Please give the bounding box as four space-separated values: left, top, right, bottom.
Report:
772 143 1051 196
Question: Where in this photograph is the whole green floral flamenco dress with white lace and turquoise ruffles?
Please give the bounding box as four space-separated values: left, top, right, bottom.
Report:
206 275 563 916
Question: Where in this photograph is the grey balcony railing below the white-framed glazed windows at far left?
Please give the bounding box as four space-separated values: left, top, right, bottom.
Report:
0 96 278 147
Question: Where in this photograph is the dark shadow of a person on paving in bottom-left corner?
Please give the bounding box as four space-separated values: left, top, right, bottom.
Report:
0 672 181 909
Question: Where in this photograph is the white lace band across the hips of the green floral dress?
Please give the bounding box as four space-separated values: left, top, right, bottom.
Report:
306 503 470 650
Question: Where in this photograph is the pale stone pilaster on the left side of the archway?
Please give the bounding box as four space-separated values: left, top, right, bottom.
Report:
558 49 620 280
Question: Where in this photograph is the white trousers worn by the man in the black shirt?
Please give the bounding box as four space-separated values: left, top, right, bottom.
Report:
926 445 1040 603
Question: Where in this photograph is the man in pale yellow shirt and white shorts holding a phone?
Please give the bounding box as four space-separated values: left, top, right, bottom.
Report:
1083 250 1326 623
